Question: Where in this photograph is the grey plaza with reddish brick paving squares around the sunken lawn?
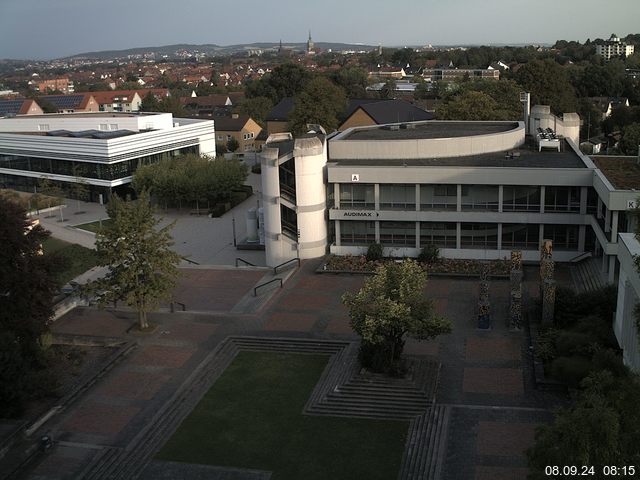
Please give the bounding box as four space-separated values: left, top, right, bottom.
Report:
12 261 557 480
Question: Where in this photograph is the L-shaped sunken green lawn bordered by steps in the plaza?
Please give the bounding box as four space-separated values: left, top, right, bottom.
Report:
157 352 409 480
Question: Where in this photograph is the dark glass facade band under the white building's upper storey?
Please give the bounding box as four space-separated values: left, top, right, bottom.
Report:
0 146 198 180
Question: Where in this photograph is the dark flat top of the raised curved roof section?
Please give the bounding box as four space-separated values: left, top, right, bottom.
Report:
336 121 518 140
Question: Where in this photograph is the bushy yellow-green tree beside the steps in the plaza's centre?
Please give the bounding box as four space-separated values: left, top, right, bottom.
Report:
342 260 451 373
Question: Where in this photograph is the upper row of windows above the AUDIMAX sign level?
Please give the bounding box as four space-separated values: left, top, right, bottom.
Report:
339 184 597 213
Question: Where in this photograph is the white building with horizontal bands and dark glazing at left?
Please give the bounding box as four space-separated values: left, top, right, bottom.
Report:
0 112 216 201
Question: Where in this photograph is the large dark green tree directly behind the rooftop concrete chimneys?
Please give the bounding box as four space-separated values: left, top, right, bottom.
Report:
515 59 577 114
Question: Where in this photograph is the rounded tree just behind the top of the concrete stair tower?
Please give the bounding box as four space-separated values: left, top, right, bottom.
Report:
289 77 347 134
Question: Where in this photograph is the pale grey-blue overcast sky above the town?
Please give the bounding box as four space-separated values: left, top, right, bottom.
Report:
0 0 640 59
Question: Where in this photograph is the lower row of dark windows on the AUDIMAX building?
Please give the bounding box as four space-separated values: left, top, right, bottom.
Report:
340 221 578 250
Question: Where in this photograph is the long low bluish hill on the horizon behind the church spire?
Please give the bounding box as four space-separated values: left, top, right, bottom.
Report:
62 42 377 60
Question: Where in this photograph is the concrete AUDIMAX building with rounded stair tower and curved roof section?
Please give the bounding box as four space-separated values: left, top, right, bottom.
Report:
261 106 640 367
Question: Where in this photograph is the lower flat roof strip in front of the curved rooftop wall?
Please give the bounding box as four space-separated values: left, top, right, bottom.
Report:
329 139 587 168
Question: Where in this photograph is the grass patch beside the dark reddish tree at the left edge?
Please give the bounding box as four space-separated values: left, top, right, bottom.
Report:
42 237 98 286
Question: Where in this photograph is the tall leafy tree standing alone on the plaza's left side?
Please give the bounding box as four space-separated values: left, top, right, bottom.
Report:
86 192 180 330
